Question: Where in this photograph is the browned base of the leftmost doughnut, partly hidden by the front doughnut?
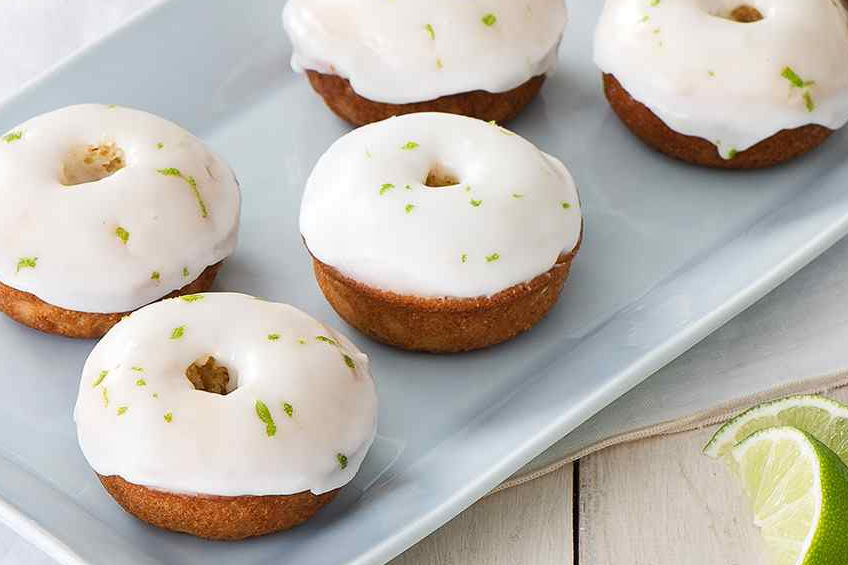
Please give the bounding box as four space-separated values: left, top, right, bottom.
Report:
0 261 223 339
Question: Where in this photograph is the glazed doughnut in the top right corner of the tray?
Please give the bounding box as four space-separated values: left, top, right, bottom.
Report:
594 0 848 169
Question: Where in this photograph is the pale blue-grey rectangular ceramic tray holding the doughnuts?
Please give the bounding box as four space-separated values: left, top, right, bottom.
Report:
0 0 848 565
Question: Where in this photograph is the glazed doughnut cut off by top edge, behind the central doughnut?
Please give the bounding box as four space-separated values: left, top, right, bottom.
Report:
283 0 567 126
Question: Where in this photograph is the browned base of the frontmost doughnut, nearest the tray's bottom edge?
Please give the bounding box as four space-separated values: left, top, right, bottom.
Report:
97 475 339 541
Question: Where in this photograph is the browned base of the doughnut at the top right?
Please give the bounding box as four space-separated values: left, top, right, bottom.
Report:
604 74 833 169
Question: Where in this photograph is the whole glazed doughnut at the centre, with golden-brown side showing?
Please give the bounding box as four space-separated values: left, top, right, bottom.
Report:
300 113 583 353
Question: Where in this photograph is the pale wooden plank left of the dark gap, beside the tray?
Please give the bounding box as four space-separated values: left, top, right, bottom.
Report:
392 465 574 565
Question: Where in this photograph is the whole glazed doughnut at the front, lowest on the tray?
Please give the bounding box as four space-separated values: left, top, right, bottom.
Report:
74 293 377 540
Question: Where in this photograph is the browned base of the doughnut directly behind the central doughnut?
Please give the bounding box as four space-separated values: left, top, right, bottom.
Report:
306 71 545 126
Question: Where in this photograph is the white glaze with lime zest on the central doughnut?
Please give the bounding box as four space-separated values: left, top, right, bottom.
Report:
300 113 582 297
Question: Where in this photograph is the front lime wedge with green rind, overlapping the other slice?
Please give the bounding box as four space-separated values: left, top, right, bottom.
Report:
731 427 848 565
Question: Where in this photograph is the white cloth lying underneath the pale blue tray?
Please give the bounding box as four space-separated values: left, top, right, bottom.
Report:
0 4 848 565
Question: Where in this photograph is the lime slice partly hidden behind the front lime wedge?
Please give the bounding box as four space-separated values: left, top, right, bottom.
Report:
704 396 848 464
